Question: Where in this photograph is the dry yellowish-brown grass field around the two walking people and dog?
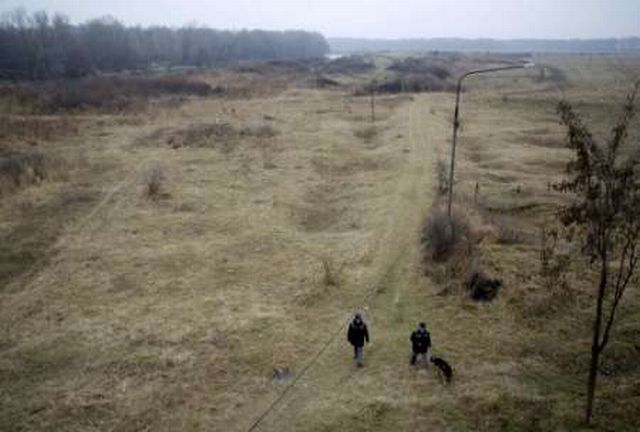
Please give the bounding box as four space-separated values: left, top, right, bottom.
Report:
0 56 640 431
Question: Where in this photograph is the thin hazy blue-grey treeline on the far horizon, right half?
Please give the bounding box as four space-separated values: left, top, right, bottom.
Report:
329 37 640 54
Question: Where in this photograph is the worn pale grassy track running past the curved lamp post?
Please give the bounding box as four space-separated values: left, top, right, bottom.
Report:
248 97 445 431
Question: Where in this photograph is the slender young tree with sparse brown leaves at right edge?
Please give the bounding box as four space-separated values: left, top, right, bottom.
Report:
556 81 640 423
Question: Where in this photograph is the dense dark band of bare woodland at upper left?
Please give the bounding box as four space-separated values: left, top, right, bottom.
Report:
0 10 329 80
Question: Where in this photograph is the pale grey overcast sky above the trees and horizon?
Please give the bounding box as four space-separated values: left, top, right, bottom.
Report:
0 0 640 39
